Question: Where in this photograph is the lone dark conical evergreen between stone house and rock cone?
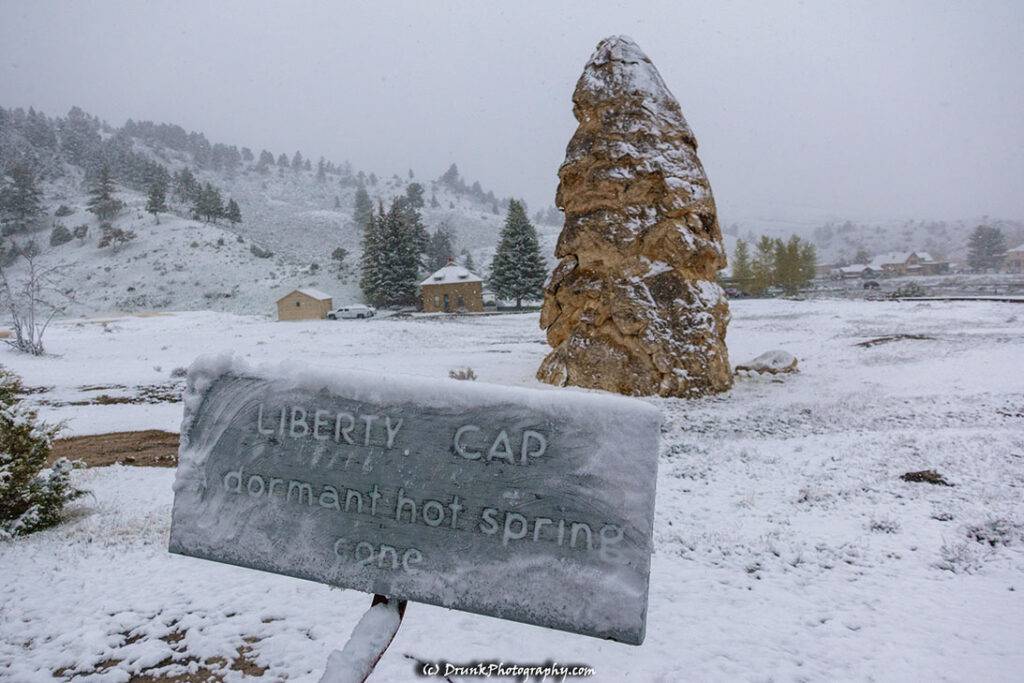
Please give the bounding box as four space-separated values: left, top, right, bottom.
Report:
490 200 547 308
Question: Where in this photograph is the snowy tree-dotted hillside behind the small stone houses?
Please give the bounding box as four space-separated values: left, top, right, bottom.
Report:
0 108 558 314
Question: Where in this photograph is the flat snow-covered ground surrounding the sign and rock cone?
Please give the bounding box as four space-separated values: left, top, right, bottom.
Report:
0 300 1024 681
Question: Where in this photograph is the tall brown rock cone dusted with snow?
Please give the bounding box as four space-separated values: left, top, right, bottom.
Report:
538 36 732 397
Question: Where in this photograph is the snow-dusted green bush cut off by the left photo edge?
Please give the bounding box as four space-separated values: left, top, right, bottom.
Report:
0 369 85 541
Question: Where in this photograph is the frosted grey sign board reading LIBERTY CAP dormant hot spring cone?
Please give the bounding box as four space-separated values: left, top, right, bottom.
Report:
170 356 660 644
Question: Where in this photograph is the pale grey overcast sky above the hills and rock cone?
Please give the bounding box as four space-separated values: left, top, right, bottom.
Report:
0 0 1024 224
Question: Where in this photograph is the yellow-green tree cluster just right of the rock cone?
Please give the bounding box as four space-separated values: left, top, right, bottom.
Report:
731 234 817 296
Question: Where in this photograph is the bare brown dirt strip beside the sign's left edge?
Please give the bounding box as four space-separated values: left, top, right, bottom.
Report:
50 429 178 467
